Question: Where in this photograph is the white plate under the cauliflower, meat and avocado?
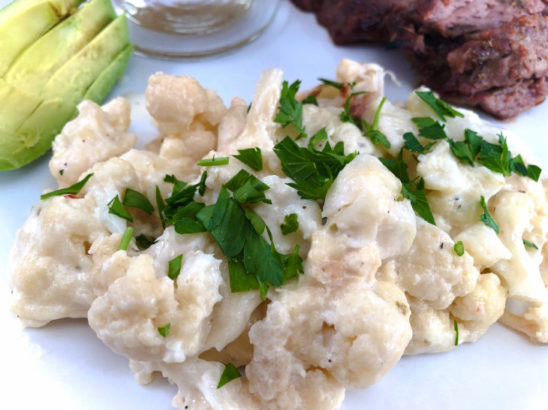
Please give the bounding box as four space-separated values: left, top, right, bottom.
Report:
0 0 548 410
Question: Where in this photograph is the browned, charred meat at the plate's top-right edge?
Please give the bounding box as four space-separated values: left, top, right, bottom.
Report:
293 0 548 118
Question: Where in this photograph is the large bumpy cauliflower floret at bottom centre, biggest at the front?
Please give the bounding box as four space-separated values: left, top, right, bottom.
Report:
246 275 411 408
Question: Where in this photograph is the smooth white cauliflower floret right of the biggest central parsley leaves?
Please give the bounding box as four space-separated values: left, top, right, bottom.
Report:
323 154 416 259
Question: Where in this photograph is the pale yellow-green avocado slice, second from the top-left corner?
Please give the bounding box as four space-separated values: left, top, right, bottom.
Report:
4 0 116 95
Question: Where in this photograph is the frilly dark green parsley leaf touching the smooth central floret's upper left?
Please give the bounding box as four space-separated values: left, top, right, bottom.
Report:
274 137 357 200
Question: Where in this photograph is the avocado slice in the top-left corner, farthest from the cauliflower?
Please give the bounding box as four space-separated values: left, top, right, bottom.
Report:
0 0 83 77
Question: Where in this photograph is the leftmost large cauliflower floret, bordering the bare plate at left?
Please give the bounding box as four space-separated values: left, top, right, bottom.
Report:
9 196 108 326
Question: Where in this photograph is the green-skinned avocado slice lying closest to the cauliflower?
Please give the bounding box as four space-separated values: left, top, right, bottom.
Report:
0 15 129 170
